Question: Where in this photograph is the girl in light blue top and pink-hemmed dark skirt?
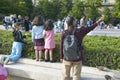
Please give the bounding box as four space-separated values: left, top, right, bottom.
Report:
32 15 44 61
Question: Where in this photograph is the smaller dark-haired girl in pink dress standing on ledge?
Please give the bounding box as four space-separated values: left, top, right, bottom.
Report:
43 19 55 62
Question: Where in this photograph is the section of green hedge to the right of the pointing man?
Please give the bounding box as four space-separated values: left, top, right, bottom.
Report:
83 36 120 69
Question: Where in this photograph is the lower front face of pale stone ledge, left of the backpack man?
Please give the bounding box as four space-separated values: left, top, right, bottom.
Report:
5 63 60 80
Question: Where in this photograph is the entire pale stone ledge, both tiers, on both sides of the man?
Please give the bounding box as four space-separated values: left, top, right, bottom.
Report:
0 55 119 80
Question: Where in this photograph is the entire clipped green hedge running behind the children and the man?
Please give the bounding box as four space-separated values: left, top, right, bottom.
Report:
0 31 120 70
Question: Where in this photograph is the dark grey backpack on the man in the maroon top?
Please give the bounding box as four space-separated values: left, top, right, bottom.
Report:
63 28 80 61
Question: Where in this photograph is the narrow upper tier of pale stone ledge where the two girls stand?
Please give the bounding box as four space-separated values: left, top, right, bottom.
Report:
18 58 113 76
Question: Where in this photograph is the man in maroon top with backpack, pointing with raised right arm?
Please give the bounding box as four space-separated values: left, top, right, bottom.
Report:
60 16 103 80
